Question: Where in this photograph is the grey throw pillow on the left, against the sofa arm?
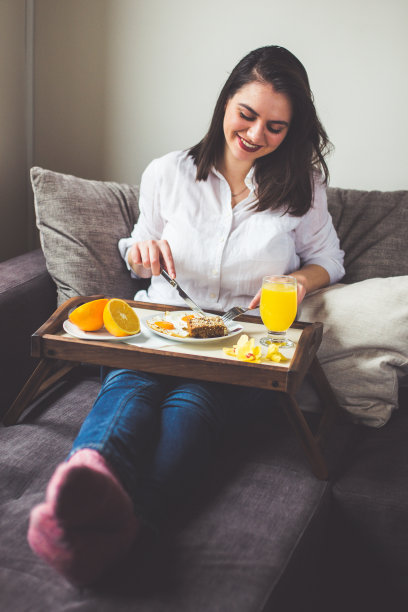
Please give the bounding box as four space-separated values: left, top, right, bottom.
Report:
31 167 140 304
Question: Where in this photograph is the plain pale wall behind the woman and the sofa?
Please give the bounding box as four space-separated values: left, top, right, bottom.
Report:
0 0 408 260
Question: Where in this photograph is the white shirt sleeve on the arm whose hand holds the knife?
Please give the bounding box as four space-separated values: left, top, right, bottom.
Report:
118 160 164 278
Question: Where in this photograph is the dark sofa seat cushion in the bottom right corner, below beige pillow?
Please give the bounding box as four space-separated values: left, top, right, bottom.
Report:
332 402 408 610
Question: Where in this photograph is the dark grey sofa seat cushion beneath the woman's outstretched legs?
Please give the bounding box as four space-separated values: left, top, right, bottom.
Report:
0 378 330 612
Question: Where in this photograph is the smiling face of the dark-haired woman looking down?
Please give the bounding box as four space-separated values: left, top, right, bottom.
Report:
224 81 292 169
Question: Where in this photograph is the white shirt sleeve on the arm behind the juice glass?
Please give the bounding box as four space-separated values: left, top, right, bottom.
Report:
295 179 345 284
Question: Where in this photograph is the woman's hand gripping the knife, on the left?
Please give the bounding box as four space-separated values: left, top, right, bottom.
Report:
127 240 176 278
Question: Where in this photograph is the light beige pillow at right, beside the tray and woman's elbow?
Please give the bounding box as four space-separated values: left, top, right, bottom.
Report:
298 276 408 427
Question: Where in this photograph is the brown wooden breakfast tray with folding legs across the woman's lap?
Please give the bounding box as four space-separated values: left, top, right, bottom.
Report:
3 296 339 479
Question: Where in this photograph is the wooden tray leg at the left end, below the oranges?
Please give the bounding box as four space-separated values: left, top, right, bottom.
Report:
3 358 77 426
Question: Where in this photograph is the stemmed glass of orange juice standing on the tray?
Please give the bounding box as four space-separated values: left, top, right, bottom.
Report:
260 276 297 347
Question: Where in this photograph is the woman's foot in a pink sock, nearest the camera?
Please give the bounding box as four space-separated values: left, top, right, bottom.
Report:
27 449 140 585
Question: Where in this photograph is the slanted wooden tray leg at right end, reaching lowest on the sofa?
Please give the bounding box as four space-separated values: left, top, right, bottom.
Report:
283 394 329 480
